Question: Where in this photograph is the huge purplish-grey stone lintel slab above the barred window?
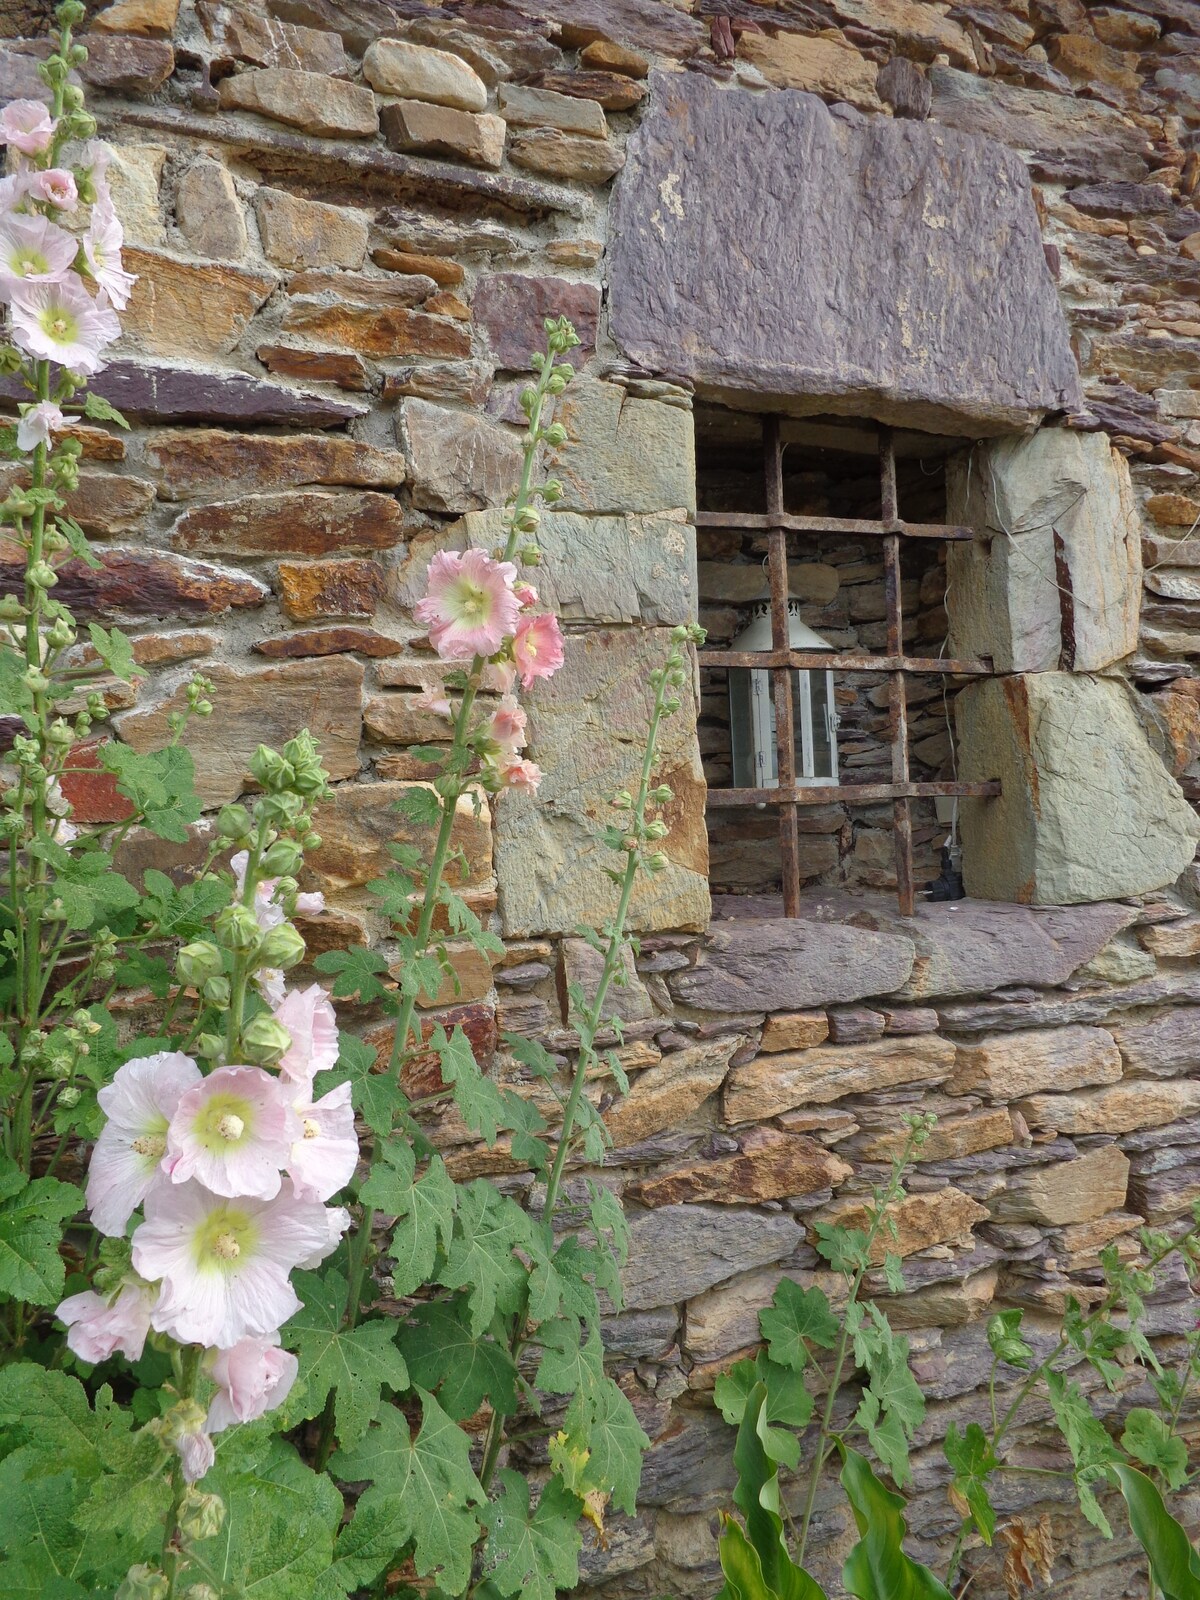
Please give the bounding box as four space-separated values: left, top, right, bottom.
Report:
610 72 1080 434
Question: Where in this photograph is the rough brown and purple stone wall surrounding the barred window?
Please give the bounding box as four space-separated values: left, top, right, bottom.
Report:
0 0 1200 1600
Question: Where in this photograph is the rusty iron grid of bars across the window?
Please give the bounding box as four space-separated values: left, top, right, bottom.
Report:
696 416 1000 917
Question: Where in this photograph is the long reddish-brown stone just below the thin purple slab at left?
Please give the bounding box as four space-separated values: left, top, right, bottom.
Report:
146 427 405 499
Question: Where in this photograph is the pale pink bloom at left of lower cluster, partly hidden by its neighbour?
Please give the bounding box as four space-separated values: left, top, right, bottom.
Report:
88 1050 200 1238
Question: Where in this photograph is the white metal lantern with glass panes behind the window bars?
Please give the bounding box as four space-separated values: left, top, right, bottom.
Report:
728 600 837 789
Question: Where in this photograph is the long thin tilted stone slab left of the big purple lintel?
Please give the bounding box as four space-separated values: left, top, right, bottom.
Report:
99 101 586 218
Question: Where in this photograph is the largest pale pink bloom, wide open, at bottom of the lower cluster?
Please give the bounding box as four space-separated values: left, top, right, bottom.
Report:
133 1182 349 1350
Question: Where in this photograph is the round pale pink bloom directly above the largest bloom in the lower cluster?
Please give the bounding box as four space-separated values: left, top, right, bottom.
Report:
163 1067 301 1200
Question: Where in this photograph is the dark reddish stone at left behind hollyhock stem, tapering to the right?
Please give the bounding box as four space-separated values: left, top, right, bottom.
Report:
0 549 270 621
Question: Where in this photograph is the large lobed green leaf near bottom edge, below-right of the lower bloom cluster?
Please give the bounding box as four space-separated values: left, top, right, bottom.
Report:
330 1389 486 1594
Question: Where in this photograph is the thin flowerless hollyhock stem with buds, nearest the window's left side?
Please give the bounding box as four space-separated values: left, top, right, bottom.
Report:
478 659 670 1493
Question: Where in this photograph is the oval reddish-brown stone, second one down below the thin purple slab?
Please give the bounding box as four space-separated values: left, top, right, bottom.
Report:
171 490 402 555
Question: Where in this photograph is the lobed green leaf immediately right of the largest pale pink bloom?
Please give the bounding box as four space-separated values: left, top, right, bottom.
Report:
285 1272 408 1445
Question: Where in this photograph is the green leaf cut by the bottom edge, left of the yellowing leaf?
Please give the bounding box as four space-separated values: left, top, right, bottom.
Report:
483 1467 582 1600
